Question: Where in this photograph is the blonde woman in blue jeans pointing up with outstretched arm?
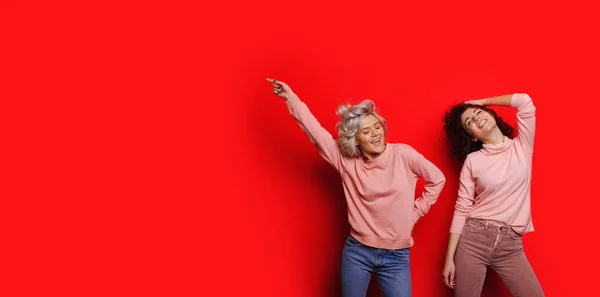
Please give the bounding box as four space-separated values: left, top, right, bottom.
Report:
267 79 445 297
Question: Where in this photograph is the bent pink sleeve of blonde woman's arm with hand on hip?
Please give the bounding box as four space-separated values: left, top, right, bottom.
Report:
408 148 446 223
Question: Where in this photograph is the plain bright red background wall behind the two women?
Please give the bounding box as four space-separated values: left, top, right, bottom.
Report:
0 1 599 297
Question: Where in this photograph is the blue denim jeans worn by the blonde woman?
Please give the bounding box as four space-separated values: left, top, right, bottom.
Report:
340 236 412 297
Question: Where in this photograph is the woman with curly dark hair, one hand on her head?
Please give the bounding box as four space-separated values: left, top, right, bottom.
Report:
442 93 544 297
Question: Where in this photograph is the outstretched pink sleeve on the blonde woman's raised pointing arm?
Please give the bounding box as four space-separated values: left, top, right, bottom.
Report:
286 97 342 171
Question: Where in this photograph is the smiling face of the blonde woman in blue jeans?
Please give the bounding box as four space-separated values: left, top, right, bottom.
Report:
356 114 385 159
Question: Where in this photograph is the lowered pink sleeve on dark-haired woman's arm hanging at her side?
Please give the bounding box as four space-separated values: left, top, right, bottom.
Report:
450 157 475 234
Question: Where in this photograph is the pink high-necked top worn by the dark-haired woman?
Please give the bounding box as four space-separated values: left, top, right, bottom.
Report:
450 94 535 234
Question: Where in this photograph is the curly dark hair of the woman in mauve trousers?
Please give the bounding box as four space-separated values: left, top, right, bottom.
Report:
444 103 515 162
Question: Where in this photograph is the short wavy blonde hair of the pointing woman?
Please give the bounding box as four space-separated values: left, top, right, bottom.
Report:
336 99 387 157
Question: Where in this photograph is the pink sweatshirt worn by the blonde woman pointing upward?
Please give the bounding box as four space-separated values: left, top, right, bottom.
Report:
286 98 446 249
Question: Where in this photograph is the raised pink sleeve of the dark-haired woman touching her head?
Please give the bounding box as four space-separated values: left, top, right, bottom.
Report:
510 93 536 154
